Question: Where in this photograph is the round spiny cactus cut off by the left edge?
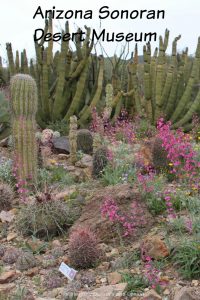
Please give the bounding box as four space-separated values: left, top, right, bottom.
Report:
0 183 14 211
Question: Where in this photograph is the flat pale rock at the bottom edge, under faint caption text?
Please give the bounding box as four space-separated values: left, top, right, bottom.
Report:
77 283 127 300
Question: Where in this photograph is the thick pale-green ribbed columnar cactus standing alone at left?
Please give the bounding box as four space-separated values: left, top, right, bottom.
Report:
11 74 38 186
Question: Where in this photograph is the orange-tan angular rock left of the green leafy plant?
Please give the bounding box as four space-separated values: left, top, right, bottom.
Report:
141 236 169 259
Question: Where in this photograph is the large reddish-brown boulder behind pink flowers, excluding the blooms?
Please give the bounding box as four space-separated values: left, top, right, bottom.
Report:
70 183 155 244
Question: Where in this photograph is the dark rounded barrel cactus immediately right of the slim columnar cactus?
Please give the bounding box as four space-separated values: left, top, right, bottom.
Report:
77 129 93 155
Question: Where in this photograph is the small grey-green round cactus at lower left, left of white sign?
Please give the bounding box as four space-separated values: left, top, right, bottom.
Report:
16 252 36 271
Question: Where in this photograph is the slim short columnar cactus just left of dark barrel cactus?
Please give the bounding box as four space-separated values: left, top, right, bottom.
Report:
69 116 78 164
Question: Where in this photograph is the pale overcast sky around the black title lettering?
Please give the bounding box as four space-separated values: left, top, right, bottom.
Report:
0 0 200 62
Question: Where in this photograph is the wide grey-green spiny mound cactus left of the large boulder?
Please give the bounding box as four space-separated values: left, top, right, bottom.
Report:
16 194 81 239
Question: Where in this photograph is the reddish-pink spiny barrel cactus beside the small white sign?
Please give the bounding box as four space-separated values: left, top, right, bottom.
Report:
69 228 100 269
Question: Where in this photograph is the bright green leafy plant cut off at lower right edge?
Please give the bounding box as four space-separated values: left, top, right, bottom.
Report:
173 240 200 279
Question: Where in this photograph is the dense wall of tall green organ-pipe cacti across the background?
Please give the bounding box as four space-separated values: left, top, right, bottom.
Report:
3 22 200 128
